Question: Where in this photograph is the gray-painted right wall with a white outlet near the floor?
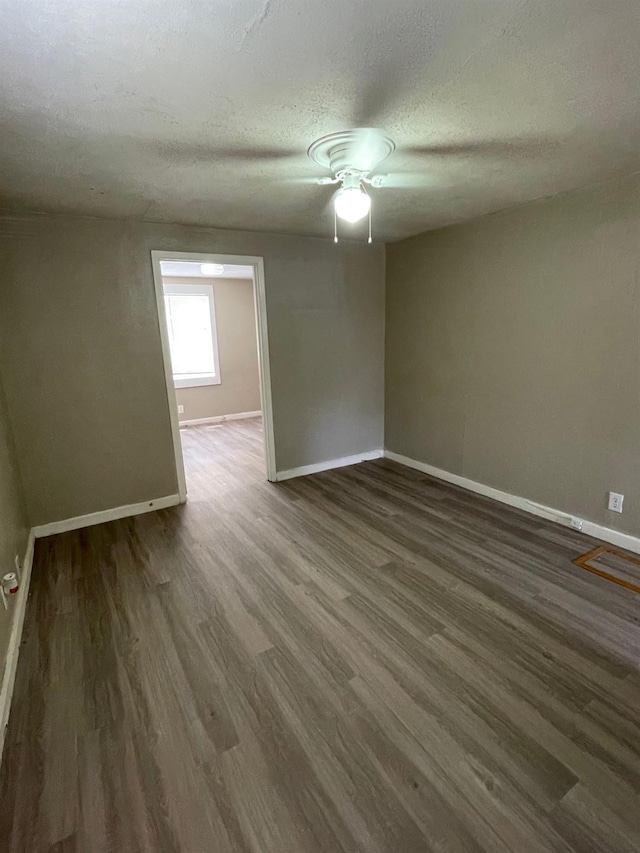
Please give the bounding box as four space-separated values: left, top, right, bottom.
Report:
385 170 640 535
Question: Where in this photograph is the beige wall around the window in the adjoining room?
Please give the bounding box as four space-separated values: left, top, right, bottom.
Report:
168 277 261 421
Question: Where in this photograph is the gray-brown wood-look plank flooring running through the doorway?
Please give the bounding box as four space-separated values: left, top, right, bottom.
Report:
0 421 640 853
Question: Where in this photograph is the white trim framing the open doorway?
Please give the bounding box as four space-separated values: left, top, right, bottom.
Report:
151 249 276 503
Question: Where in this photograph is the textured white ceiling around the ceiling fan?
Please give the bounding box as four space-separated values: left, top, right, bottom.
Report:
0 0 640 239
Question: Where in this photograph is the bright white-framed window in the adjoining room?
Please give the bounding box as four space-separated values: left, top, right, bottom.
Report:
164 284 221 388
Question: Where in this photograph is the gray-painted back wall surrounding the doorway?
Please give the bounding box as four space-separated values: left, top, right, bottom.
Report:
0 215 384 525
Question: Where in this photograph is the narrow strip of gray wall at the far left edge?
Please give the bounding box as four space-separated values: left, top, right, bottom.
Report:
0 366 29 682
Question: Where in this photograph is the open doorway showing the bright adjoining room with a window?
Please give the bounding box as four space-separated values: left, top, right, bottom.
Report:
151 250 276 502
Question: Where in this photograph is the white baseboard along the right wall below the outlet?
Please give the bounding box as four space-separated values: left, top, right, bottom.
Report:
384 450 640 554
